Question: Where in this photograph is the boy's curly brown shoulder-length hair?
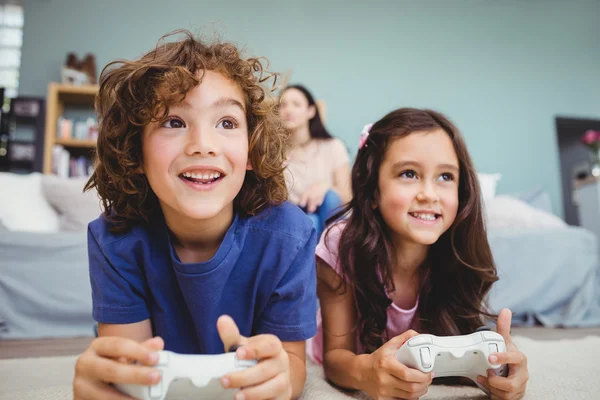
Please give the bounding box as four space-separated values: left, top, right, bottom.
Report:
84 30 289 233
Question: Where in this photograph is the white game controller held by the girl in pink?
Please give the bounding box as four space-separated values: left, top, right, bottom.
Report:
396 331 508 395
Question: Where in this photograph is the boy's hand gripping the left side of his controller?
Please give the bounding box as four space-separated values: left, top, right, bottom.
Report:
73 336 164 400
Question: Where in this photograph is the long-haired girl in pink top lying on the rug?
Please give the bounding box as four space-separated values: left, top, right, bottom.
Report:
309 108 528 399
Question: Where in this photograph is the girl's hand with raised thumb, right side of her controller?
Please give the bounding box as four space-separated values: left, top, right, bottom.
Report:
477 308 529 400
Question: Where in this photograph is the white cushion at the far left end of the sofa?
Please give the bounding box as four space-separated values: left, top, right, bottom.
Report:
0 172 59 232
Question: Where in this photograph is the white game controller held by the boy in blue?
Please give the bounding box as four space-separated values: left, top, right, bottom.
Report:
114 351 256 400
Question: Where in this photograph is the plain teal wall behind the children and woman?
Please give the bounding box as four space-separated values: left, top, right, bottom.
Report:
20 0 600 214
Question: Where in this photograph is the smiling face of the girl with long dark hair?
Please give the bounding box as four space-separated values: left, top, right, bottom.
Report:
377 129 460 245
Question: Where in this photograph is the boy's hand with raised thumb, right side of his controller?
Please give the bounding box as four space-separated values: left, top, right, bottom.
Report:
217 316 292 400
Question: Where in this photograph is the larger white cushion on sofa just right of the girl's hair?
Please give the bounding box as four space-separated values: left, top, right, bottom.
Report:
486 195 568 229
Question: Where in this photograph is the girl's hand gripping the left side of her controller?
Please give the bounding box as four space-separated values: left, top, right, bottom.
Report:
363 330 433 400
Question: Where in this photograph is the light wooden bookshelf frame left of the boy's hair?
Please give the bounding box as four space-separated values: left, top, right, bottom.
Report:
43 82 98 174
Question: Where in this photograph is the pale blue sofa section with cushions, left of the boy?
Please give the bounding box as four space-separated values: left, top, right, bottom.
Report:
0 172 101 339
